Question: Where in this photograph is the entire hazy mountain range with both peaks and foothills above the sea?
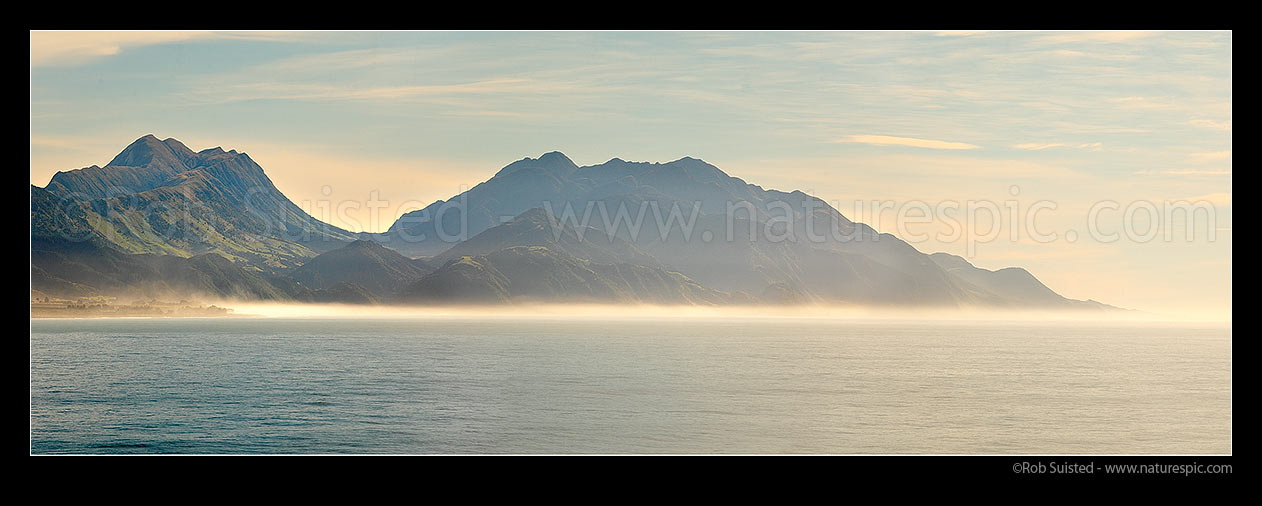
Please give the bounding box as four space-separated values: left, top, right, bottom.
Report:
30 135 1108 308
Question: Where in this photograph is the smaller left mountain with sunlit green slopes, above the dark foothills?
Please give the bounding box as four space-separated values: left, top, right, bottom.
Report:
32 135 353 268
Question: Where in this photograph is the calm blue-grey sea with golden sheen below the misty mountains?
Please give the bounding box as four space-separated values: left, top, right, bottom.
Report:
30 318 1232 454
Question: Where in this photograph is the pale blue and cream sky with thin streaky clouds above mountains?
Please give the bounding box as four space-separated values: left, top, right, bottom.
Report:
30 30 1232 318
